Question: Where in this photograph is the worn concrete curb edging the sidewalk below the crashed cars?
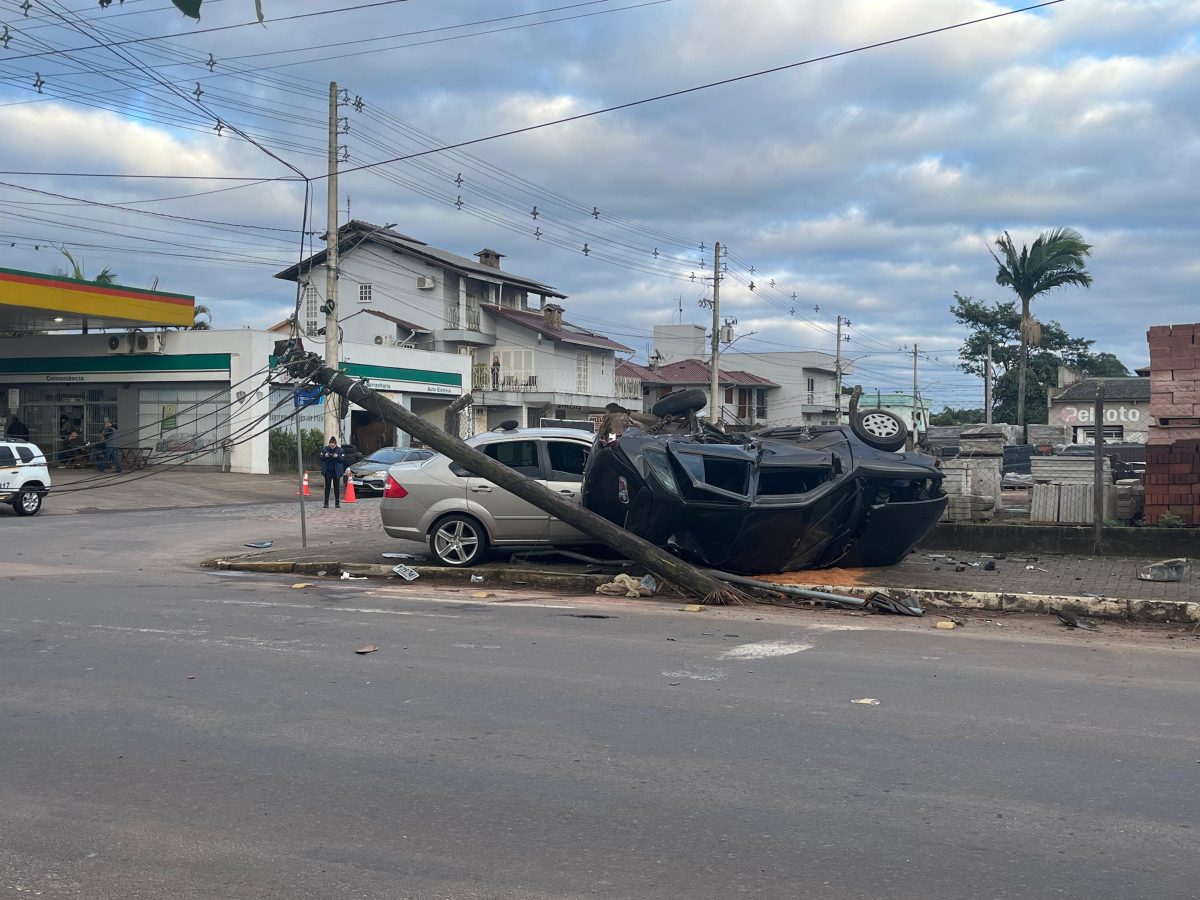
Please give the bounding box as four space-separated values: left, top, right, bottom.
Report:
202 557 1200 623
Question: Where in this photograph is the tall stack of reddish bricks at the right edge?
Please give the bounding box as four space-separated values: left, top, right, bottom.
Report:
1146 324 1200 524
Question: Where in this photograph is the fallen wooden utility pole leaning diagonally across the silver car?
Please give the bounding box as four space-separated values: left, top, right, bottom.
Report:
280 352 744 605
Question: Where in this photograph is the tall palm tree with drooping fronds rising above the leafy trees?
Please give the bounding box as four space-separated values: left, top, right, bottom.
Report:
988 228 1092 425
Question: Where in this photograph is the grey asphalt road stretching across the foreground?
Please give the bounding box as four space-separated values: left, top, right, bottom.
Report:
0 509 1200 900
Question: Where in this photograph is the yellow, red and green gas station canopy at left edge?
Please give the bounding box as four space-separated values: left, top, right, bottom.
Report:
0 269 196 332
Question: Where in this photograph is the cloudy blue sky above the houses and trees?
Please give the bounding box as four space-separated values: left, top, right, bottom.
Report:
0 0 1200 406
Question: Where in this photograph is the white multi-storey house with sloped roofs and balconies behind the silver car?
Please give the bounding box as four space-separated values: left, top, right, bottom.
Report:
276 221 632 432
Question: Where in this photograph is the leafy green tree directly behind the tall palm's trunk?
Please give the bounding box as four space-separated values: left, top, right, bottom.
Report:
950 292 1129 424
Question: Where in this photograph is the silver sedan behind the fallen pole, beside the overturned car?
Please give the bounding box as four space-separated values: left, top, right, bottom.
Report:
379 428 592 566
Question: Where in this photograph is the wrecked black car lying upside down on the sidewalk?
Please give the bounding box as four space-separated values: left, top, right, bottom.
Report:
583 391 947 575
